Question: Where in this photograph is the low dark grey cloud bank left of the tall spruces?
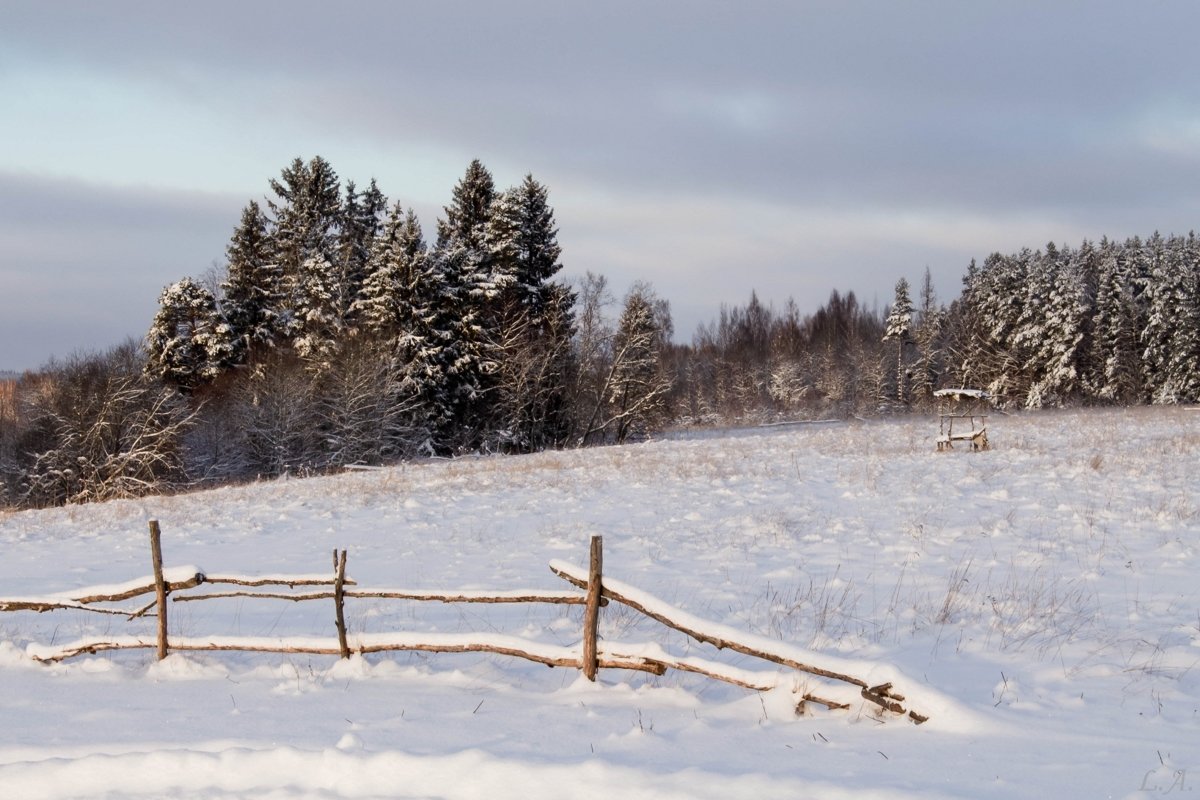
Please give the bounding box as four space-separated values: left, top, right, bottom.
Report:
0 173 242 369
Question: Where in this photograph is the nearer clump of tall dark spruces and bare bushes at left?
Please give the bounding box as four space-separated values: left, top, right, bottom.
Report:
0 157 671 506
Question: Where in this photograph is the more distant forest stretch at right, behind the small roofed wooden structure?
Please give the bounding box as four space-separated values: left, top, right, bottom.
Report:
673 233 1200 425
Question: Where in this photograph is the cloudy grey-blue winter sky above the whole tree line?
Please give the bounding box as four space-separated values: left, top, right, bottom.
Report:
0 0 1200 369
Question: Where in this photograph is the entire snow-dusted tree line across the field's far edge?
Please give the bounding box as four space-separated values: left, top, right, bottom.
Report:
0 157 1200 506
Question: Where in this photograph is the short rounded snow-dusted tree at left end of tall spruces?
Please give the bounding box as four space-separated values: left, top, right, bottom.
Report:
145 278 234 392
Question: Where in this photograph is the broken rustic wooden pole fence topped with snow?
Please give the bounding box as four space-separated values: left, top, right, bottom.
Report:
0 521 929 724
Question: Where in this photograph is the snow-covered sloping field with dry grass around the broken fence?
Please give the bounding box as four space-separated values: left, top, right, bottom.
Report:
0 409 1200 800
